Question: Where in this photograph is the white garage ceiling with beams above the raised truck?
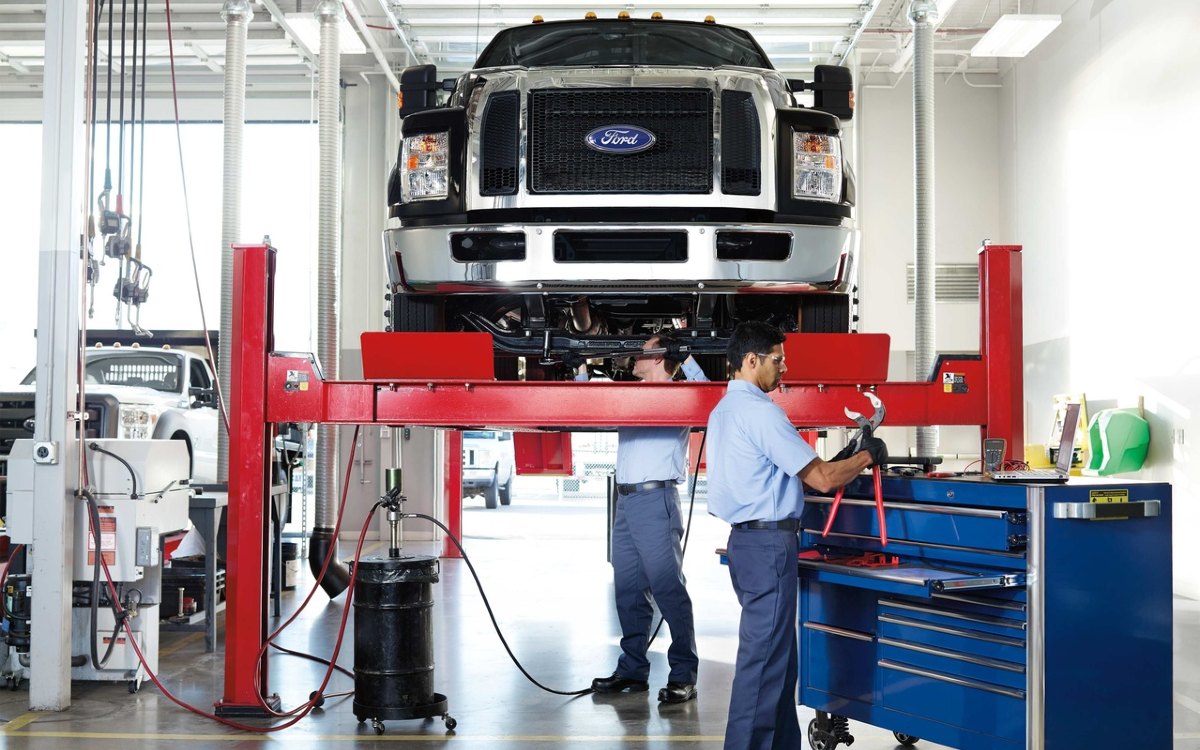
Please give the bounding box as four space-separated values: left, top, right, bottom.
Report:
0 0 1016 98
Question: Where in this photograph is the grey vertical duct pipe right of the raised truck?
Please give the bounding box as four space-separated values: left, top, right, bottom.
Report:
908 0 937 456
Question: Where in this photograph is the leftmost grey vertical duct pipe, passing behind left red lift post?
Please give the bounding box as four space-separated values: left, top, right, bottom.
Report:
215 0 254 484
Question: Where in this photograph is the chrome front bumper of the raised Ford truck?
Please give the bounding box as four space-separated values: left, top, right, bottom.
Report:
384 223 856 293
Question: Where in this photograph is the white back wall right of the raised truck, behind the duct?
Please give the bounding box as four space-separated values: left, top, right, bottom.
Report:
856 76 1020 461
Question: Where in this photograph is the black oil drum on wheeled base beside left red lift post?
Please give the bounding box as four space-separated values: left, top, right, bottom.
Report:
354 556 446 725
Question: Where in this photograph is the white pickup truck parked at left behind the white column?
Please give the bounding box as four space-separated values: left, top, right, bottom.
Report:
0 344 218 484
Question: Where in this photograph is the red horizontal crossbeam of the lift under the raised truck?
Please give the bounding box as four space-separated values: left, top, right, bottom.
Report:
266 357 988 428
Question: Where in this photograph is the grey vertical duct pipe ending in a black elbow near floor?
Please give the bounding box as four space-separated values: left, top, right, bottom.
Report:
308 0 350 599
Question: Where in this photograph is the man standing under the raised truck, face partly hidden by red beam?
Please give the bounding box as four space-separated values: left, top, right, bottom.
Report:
576 331 708 703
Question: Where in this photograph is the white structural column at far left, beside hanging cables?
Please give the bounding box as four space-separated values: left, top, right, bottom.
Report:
29 2 88 710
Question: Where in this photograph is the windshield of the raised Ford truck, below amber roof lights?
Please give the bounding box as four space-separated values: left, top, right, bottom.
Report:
475 19 772 70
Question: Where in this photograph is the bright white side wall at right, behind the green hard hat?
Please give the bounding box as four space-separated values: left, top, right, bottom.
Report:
1000 0 1200 598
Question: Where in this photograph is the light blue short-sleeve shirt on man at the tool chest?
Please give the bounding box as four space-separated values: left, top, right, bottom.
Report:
707 380 817 523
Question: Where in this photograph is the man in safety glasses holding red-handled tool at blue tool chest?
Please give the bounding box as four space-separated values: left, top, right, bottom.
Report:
707 322 887 750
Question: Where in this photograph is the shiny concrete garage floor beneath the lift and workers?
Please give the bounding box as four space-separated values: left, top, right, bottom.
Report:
0 494 1200 750
